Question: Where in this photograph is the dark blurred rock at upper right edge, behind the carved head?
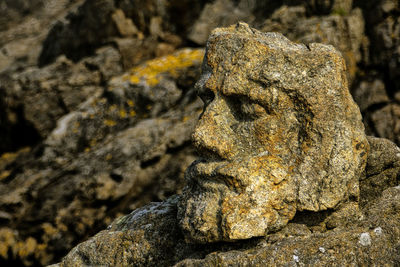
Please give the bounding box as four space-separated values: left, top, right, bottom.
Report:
354 0 400 145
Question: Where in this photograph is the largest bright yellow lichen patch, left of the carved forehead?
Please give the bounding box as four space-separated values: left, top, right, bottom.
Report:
124 49 204 86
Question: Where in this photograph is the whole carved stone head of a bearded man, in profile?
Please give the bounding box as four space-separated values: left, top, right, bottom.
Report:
178 23 369 243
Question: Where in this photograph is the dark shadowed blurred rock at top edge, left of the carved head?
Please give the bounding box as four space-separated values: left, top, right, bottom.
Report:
39 0 204 68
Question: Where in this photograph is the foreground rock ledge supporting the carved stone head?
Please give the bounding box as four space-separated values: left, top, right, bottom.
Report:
60 137 400 266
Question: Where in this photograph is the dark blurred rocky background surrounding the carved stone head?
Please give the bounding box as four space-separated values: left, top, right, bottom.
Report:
0 0 400 265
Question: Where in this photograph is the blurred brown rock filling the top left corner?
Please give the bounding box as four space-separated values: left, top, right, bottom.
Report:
0 0 82 72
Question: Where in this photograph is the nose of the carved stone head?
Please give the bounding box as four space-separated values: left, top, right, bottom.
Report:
192 97 238 159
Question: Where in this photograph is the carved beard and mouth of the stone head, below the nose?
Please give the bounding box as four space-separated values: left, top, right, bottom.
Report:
178 161 296 243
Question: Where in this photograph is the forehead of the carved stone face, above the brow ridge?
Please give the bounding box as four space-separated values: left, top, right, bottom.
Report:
200 34 291 102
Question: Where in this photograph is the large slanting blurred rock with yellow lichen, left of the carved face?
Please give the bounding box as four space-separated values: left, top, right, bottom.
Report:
0 48 204 265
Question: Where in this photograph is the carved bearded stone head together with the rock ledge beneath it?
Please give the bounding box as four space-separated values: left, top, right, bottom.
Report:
59 24 400 266
